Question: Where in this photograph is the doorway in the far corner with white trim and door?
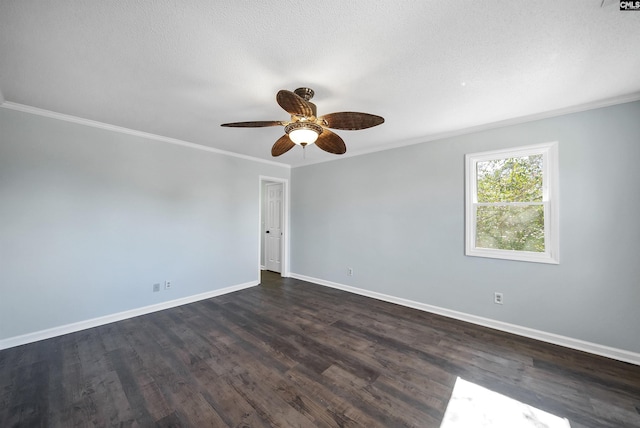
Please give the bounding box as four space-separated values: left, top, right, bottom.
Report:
260 177 288 276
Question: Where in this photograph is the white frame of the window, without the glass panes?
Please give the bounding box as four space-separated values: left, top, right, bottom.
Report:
465 142 560 264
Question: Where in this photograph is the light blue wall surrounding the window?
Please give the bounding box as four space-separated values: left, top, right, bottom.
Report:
291 102 640 352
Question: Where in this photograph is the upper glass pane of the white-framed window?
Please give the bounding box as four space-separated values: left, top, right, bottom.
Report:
476 155 543 202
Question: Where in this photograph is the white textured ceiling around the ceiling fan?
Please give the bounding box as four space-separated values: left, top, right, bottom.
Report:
0 0 640 166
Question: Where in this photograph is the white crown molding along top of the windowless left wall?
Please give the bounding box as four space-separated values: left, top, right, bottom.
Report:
0 101 291 168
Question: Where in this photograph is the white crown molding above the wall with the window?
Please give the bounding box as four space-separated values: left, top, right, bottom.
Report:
293 92 640 168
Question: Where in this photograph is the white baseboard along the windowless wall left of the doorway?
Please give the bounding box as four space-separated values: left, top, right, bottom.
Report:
0 281 260 350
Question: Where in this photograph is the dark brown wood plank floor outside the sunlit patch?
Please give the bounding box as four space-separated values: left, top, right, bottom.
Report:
0 272 640 428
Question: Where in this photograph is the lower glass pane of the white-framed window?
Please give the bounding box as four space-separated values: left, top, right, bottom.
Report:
476 205 545 253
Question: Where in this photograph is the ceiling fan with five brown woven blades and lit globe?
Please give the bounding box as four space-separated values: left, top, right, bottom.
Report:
221 88 384 156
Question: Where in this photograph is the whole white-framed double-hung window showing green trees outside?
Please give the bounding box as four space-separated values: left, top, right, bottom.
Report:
465 143 558 264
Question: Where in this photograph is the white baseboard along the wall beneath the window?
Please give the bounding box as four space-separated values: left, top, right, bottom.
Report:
291 273 640 366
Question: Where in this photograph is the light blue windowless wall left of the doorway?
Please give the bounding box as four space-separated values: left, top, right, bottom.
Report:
0 108 290 340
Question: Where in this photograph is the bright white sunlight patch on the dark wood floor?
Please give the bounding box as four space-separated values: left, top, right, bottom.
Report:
440 378 571 428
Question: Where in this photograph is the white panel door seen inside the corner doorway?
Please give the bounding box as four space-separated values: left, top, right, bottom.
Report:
264 183 283 272
